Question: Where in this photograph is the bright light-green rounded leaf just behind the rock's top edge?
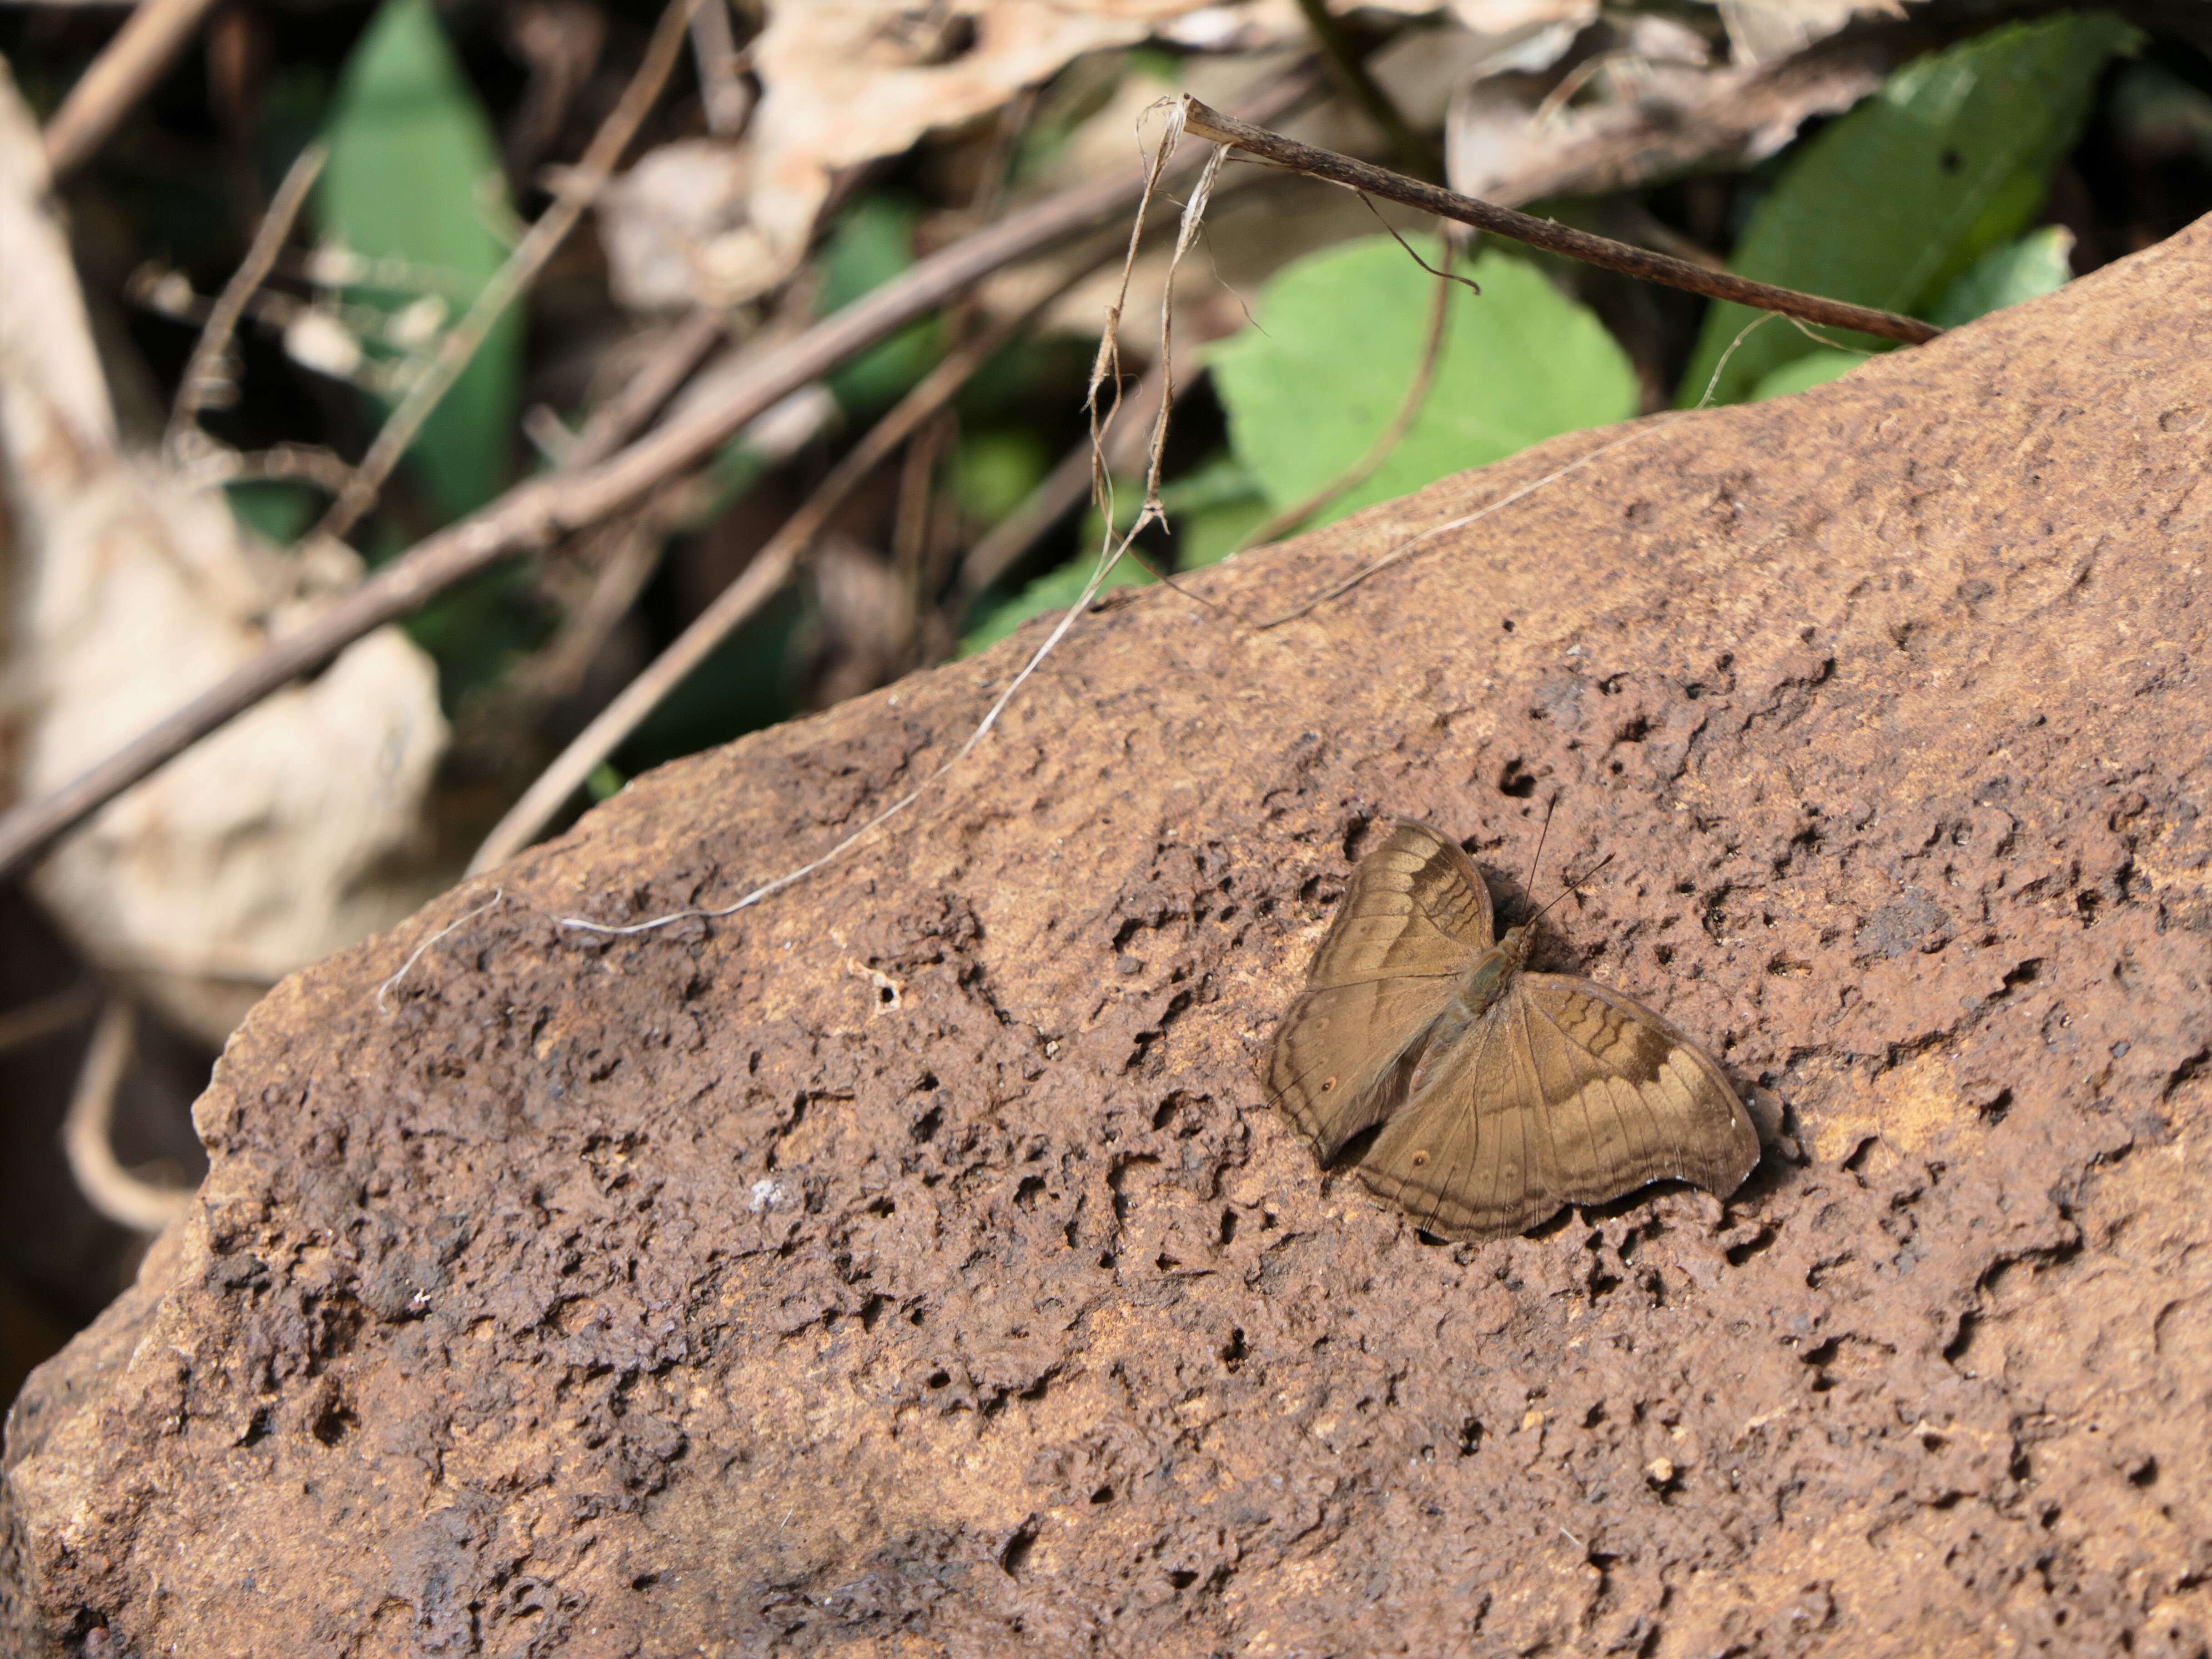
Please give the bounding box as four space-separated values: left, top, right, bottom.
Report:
1210 236 1637 527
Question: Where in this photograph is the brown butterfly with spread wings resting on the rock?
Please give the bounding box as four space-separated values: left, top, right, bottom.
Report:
1267 819 1759 1239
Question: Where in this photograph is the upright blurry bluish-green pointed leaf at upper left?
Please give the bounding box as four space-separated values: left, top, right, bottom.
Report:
317 0 522 518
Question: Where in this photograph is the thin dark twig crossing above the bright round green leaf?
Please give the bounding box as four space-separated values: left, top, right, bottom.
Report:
1183 93 1942 345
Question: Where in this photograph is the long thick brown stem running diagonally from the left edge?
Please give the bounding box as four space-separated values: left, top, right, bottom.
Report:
0 69 1314 898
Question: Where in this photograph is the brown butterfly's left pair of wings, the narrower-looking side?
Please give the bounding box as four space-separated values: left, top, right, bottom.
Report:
1265 819 1491 1159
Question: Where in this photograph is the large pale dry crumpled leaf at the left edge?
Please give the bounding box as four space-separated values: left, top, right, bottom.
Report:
0 69 447 1042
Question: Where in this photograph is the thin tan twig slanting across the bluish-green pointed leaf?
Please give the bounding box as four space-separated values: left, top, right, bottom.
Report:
318 0 704 535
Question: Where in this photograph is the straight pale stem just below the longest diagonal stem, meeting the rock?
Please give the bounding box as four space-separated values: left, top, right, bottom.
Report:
469 272 1088 876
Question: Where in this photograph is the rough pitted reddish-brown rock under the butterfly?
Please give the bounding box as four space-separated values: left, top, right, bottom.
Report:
0 221 2212 1659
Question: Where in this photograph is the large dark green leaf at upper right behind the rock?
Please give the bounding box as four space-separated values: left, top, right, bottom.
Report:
1679 13 2139 405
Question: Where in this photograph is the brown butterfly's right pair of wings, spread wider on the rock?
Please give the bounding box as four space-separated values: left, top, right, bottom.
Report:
1358 973 1759 1239
